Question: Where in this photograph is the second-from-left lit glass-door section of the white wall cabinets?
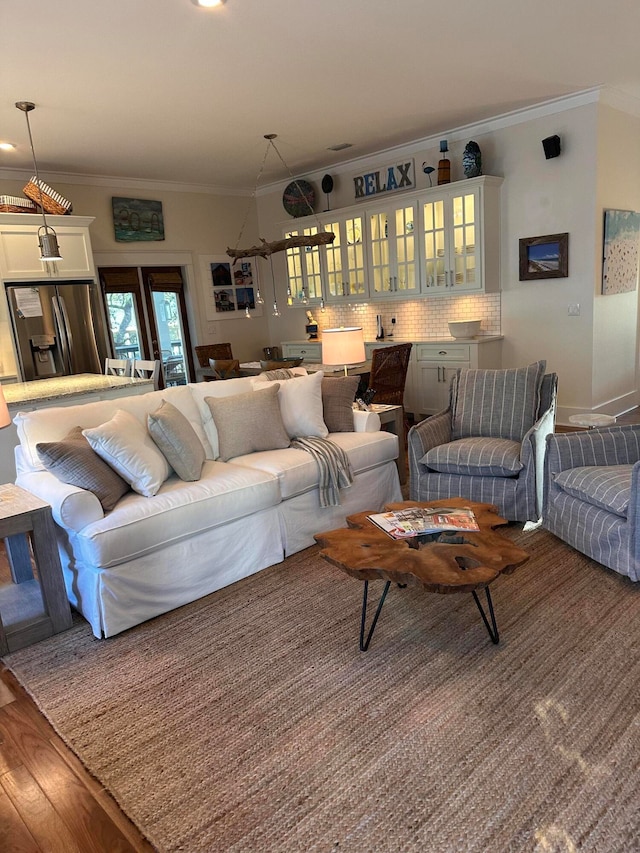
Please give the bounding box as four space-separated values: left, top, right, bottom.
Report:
320 213 368 302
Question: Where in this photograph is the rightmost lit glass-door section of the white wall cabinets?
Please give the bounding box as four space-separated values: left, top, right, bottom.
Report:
418 177 502 296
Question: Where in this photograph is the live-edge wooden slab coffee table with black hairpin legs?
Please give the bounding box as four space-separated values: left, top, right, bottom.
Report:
314 498 529 652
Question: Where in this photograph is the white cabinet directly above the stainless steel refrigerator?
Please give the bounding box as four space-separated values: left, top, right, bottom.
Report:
0 213 96 281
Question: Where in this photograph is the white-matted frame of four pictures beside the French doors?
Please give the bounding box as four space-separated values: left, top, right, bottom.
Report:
200 255 262 320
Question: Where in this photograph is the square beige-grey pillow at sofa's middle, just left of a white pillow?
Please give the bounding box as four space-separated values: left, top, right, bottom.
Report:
205 382 290 462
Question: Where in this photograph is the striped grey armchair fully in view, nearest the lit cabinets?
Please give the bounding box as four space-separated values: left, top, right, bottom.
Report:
408 361 558 522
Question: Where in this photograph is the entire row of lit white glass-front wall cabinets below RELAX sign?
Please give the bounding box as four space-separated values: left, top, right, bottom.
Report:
283 175 502 304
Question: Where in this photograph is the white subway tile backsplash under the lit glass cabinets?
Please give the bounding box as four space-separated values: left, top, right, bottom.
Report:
313 293 501 341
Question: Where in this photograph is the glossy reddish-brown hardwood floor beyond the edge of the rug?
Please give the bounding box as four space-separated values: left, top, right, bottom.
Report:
0 402 640 853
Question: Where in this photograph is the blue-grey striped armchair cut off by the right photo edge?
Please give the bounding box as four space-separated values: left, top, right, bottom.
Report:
542 424 640 581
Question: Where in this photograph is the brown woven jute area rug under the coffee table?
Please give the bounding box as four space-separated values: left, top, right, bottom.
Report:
5 526 640 853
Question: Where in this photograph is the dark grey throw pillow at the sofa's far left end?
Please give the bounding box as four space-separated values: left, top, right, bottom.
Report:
36 426 129 512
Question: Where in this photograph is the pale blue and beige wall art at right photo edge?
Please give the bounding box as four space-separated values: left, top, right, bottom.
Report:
602 210 640 296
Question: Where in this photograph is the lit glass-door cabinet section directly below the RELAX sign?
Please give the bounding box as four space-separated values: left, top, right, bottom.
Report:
366 197 420 299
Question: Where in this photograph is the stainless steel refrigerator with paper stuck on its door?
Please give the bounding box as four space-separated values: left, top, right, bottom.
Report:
5 281 108 382
